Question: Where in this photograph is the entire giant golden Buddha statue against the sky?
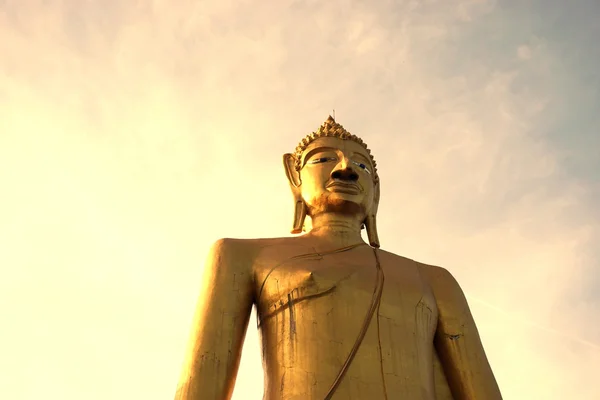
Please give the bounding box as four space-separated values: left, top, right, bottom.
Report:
175 116 502 400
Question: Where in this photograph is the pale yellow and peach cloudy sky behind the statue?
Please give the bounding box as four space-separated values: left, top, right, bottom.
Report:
0 0 600 400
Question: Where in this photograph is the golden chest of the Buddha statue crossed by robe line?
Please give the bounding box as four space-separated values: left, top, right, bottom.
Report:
251 246 437 397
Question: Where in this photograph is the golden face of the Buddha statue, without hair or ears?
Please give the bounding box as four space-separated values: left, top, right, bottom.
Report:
300 137 375 217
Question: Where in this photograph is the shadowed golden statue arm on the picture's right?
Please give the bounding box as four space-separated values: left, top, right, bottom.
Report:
426 266 502 400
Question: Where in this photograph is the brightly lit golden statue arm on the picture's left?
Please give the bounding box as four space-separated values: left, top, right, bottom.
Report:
175 239 253 400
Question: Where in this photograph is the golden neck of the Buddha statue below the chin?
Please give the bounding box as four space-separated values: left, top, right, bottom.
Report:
308 213 364 247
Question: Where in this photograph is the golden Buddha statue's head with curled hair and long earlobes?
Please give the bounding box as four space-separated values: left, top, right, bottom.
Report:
283 116 380 247
